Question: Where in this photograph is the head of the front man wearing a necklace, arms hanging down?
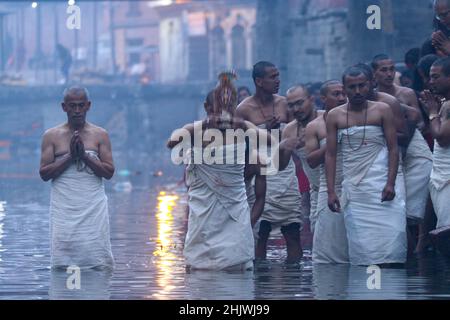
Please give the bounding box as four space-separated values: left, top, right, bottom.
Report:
342 66 370 105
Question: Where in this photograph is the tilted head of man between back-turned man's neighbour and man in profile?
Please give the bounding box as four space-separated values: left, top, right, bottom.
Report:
286 85 314 122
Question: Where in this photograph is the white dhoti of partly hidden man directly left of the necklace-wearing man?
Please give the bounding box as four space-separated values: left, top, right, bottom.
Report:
312 139 349 263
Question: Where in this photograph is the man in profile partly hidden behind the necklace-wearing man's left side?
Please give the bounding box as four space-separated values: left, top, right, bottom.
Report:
305 80 348 263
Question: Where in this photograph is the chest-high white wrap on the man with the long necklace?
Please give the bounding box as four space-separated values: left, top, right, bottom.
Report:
339 126 407 265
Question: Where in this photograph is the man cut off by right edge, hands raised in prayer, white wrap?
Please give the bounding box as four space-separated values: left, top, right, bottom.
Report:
423 58 450 229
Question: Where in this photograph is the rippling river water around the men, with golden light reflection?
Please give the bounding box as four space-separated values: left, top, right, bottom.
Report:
0 172 450 300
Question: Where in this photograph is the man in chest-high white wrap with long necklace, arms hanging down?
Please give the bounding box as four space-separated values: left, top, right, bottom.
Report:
325 67 407 265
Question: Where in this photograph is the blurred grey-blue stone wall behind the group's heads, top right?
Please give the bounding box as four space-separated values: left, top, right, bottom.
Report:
256 0 433 87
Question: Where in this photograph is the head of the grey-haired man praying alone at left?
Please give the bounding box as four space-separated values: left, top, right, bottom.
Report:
61 86 91 126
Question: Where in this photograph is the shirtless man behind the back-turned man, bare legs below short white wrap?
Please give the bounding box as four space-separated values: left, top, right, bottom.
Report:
236 61 303 263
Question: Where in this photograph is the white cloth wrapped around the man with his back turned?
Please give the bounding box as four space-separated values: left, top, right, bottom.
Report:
184 145 254 270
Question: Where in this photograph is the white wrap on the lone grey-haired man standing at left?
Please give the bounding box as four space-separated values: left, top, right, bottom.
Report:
50 151 114 268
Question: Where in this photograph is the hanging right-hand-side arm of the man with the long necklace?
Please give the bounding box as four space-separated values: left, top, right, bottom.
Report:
380 105 399 201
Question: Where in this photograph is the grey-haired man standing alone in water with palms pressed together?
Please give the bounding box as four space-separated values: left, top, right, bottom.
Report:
39 87 114 268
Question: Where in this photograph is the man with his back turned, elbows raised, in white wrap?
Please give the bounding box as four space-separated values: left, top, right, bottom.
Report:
167 73 268 271
